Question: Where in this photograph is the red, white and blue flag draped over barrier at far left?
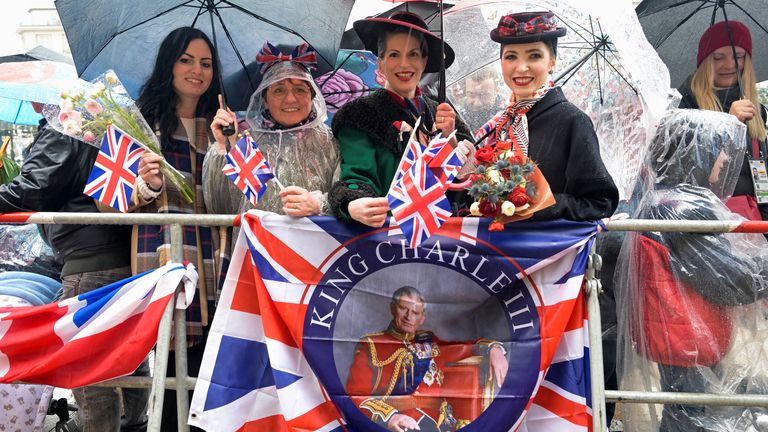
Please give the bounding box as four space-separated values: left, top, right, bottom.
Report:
0 264 197 388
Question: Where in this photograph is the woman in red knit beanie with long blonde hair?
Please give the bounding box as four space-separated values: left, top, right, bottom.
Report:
679 20 768 220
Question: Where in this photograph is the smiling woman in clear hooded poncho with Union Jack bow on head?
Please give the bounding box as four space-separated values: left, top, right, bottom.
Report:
203 43 339 217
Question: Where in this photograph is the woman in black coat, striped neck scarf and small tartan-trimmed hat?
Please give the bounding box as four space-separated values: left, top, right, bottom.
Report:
485 12 619 221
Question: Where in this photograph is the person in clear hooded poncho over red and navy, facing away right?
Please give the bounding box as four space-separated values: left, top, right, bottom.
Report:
616 110 768 432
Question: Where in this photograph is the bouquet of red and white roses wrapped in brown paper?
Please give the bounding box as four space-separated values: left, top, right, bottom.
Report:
469 141 555 231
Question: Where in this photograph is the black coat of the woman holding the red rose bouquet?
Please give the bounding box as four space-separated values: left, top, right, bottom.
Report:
527 88 619 221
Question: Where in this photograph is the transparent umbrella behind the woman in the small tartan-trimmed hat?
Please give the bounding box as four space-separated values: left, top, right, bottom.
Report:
445 0 670 198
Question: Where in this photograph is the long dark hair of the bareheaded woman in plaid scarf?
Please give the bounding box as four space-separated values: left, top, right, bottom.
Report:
137 27 221 145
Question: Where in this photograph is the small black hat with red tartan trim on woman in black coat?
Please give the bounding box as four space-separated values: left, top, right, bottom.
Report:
491 11 566 44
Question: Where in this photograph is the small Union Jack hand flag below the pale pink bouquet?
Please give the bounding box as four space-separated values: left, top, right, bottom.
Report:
83 125 144 213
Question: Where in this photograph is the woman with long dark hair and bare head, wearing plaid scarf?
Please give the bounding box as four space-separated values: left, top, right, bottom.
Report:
131 27 221 431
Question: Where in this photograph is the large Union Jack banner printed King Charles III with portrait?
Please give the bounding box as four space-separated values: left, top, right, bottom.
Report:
189 212 601 432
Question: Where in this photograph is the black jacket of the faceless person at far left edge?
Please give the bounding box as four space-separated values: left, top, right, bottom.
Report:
0 125 131 276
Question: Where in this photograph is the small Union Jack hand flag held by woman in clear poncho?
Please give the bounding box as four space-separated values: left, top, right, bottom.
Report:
222 133 275 206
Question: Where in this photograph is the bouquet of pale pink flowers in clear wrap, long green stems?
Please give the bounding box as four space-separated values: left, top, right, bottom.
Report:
43 70 194 203
